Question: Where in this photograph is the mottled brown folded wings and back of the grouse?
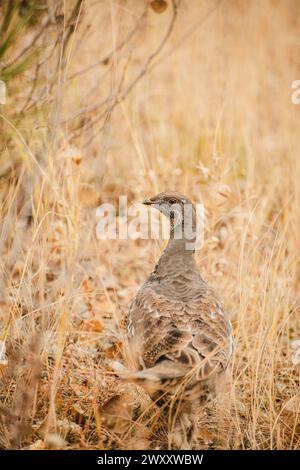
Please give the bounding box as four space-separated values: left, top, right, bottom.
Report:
128 287 231 380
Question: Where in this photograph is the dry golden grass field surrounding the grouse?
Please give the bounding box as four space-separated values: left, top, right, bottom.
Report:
0 0 300 449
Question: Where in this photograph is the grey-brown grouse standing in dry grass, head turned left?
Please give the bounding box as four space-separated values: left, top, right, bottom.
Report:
126 191 233 449
